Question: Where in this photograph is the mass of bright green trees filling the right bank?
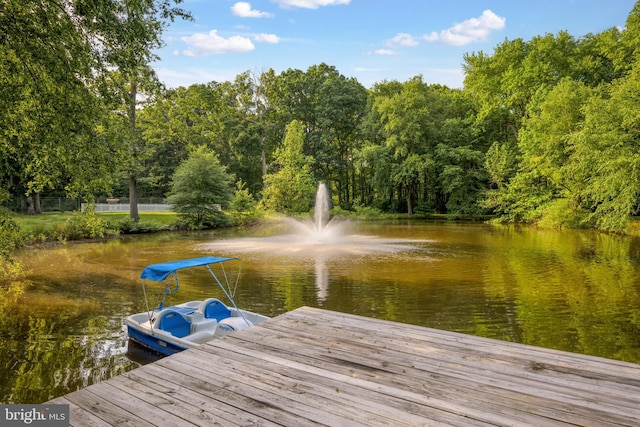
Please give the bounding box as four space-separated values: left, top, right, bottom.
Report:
466 5 640 232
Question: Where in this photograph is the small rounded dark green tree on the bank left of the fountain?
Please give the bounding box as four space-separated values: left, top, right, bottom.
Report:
167 146 234 228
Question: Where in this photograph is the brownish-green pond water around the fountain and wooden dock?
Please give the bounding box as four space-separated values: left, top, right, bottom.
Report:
0 222 640 403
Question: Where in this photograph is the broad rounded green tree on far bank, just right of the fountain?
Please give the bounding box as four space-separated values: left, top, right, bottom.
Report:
370 76 488 215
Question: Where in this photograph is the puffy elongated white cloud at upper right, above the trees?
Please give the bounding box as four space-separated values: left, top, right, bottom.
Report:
422 9 506 46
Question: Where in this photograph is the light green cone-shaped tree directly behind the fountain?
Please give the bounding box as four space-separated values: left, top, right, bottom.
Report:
262 120 316 213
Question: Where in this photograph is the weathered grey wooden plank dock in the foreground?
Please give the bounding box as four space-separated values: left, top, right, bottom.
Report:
50 307 640 427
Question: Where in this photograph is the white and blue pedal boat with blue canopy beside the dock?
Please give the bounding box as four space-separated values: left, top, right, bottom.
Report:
124 256 268 355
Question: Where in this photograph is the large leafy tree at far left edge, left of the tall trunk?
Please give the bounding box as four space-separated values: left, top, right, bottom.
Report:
0 0 119 202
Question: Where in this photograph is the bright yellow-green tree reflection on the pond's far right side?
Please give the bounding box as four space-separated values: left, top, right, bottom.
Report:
475 228 640 363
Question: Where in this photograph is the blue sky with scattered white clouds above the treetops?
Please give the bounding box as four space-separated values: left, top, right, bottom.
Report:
154 0 635 88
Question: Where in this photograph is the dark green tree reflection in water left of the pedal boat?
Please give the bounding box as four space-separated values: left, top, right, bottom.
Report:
0 299 133 403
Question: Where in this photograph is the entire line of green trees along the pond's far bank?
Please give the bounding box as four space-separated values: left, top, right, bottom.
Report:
0 0 640 232
